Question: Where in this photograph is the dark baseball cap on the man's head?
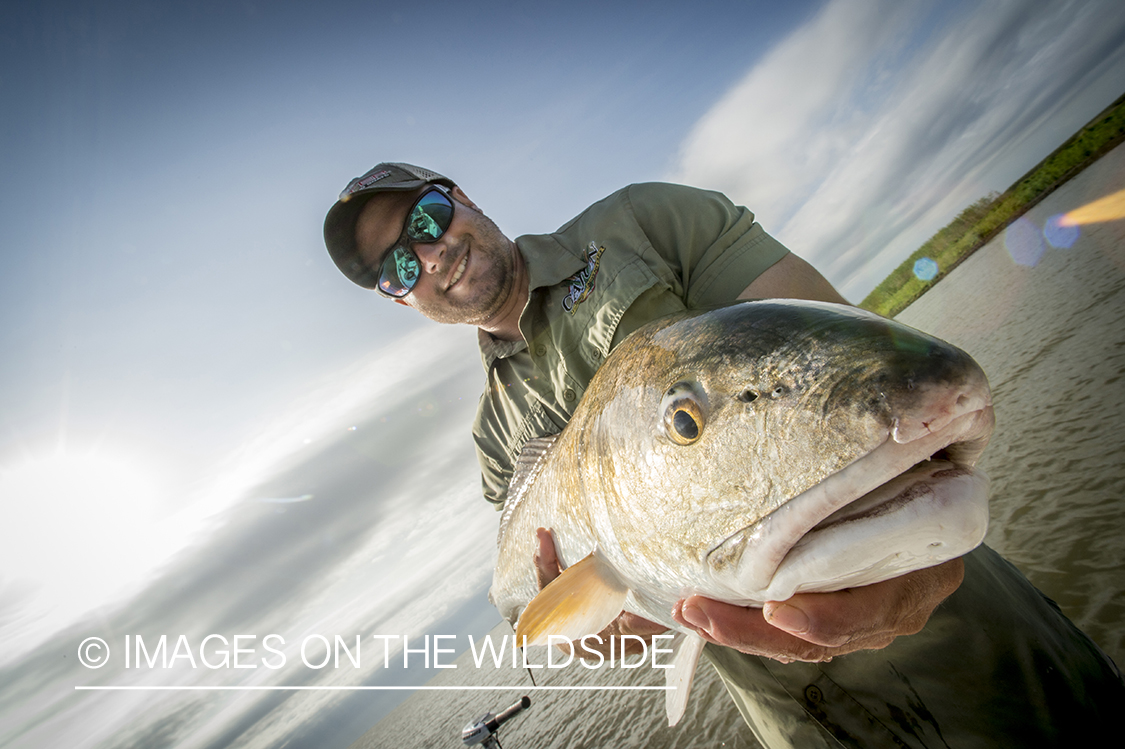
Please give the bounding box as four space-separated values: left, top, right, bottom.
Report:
324 162 456 289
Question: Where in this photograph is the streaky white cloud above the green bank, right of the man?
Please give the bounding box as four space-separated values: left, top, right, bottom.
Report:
672 0 1125 298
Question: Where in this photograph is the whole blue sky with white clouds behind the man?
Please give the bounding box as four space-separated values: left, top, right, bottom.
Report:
0 0 1125 747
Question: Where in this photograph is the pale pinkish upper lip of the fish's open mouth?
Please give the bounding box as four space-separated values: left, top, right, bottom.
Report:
707 401 995 604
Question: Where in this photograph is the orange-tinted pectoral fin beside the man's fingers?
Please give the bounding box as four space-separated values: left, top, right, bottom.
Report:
515 553 629 646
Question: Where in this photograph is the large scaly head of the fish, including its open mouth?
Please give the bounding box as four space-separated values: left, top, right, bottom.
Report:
586 300 992 604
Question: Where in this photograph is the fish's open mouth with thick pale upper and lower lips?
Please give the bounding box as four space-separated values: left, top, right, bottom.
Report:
708 389 995 605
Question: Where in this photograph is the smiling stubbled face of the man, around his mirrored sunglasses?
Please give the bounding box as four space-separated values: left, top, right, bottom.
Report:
356 186 516 325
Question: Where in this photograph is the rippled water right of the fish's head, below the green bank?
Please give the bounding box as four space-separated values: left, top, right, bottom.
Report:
899 141 1125 665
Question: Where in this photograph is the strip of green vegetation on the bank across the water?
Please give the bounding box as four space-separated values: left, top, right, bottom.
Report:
860 96 1125 317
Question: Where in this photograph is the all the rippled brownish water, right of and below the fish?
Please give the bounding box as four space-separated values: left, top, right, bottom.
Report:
353 142 1125 749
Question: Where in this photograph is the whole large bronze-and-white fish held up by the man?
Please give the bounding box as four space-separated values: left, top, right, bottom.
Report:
489 299 995 725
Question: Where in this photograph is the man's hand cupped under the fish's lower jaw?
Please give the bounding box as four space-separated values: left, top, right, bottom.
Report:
673 559 965 664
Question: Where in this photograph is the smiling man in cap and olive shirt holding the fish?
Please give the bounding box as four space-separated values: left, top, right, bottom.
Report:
325 163 1121 746
